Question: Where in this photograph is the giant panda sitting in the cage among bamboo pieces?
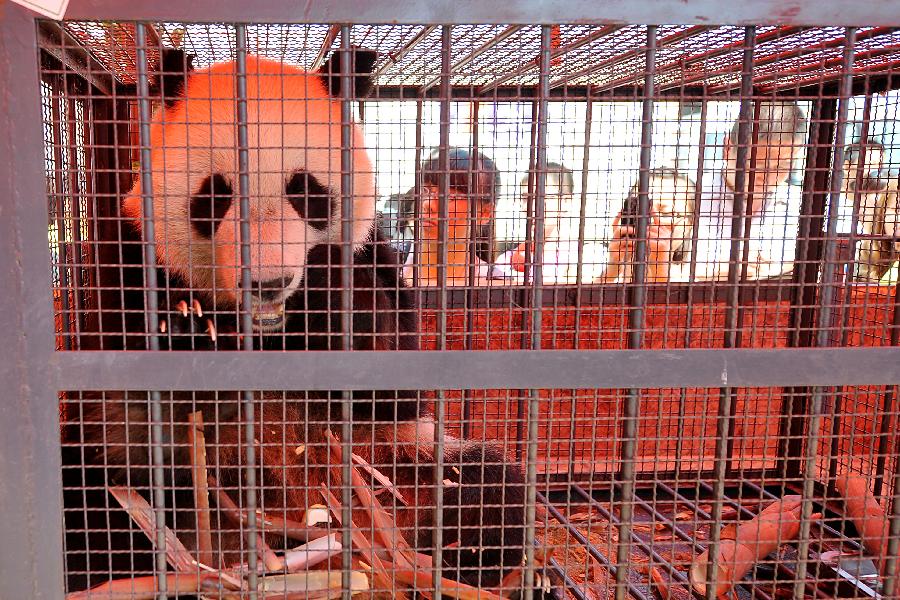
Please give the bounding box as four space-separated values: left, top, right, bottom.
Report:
62 49 540 591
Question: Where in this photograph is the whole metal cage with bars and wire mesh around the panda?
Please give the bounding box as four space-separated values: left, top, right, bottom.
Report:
0 0 900 599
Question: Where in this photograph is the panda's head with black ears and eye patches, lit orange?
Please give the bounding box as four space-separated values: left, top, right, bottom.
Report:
123 49 376 331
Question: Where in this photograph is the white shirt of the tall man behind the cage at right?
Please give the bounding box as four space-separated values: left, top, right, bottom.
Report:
695 169 801 274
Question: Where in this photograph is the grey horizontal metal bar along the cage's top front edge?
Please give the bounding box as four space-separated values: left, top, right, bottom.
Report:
66 0 900 26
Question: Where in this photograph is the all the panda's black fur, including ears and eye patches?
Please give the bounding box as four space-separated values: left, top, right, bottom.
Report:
62 49 548 591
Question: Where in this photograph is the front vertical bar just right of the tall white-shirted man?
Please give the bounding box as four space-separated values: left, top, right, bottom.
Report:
794 27 856 597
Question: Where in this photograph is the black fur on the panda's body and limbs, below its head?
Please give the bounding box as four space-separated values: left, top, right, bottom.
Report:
63 223 540 591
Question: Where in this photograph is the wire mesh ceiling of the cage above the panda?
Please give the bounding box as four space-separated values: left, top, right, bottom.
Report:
54 22 900 93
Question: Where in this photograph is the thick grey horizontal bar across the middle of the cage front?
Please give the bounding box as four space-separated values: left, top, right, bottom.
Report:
48 348 900 390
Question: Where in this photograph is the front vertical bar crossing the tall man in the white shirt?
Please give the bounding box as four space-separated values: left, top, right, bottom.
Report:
706 26 756 600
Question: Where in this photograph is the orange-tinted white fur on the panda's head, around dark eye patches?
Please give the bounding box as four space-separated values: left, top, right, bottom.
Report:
126 57 375 305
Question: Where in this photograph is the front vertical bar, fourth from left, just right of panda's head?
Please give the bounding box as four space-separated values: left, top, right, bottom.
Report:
432 25 454 597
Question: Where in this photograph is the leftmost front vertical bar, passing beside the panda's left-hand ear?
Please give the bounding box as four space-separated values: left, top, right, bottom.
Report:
135 23 168 600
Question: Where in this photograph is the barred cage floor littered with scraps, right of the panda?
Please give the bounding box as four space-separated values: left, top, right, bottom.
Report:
537 481 878 600
